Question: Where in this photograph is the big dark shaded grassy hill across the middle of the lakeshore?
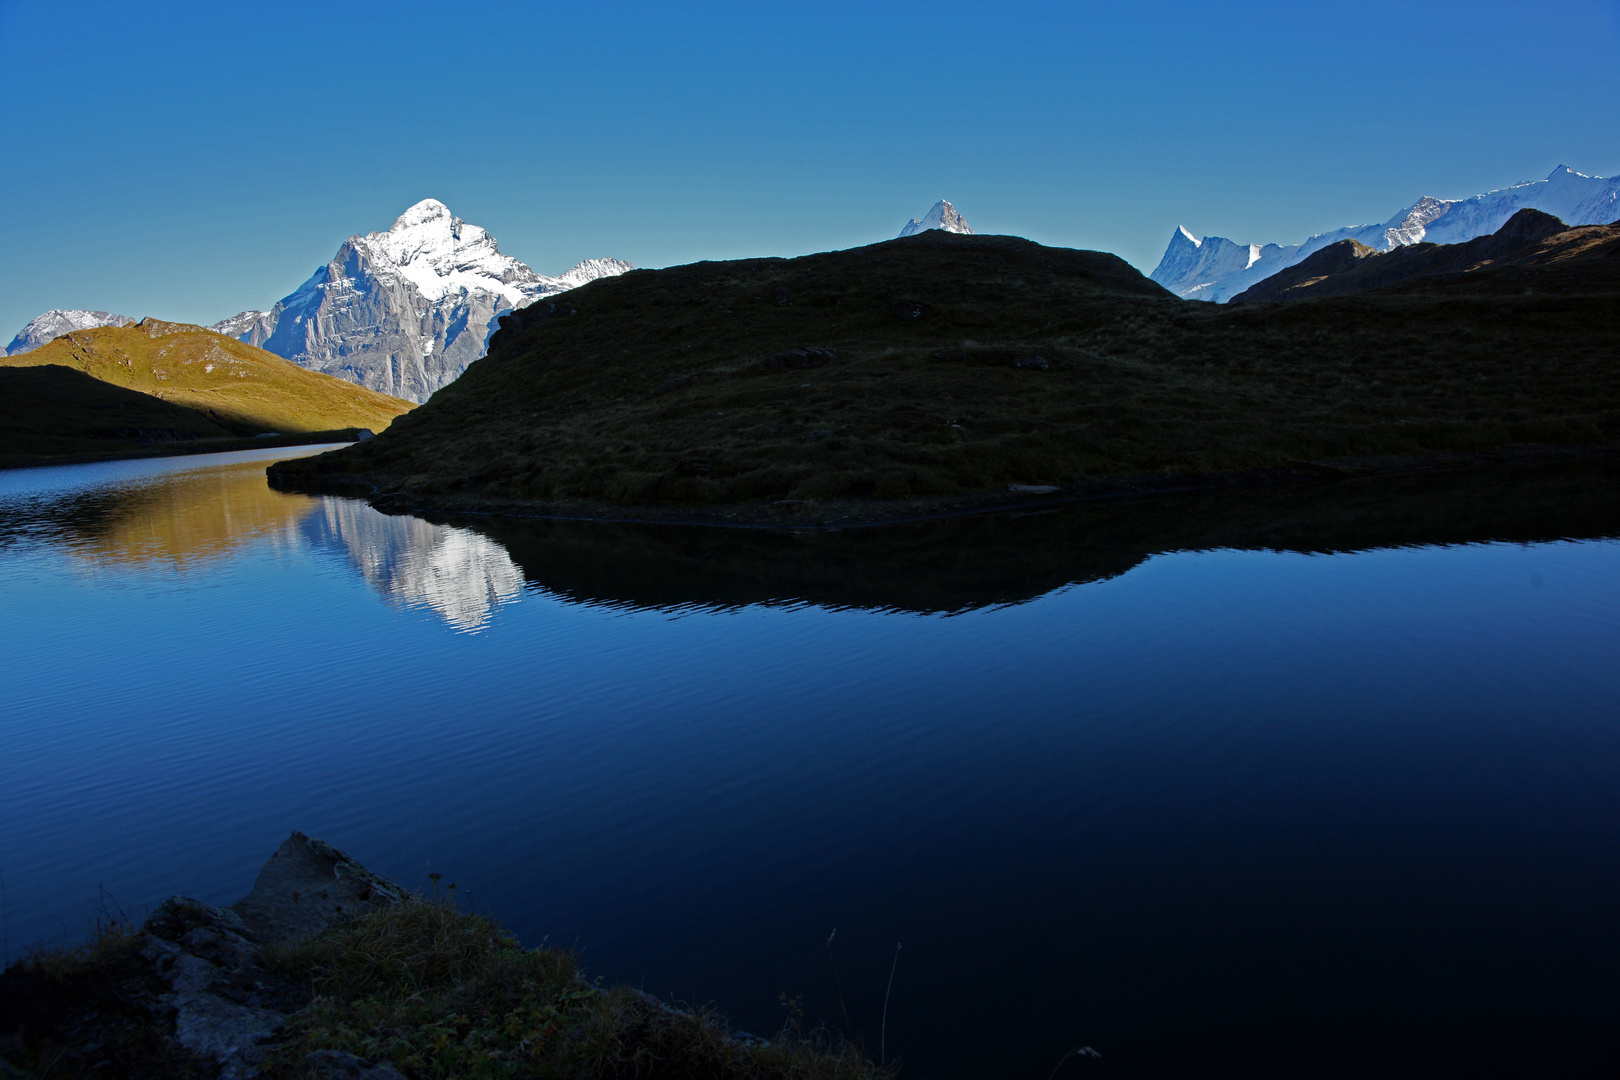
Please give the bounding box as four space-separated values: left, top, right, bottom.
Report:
271 232 1620 518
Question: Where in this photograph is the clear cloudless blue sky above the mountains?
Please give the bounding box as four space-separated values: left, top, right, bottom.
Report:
0 0 1620 333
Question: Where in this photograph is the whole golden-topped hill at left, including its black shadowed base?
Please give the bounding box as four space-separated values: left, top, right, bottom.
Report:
0 319 413 465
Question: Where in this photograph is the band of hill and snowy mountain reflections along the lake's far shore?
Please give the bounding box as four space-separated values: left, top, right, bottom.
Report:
0 452 1620 633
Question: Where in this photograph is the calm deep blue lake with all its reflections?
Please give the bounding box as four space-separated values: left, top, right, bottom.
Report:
0 450 1620 1080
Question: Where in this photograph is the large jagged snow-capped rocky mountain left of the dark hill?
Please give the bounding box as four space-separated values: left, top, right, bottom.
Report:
212 199 633 402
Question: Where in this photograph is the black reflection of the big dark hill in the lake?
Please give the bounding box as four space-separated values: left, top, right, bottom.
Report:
443 465 1620 614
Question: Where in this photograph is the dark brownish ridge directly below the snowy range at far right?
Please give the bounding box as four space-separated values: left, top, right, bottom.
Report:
1230 207 1620 304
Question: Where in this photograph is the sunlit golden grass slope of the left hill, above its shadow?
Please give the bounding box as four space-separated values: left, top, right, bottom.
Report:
0 319 415 434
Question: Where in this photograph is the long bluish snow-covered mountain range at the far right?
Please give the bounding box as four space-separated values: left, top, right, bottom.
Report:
1149 165 1620 303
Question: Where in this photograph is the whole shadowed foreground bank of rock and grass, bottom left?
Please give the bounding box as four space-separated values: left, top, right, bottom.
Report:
0 832 893 1080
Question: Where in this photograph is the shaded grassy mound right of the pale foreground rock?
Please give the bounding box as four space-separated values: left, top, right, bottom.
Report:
261 899 889 1080
